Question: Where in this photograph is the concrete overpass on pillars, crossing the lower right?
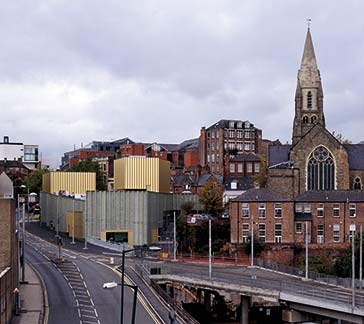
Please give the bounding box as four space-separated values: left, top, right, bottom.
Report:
140 262 364 324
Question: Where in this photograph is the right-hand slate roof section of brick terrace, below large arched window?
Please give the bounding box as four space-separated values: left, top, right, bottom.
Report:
295 190 364 202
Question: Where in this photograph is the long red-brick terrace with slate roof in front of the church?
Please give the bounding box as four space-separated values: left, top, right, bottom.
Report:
230 189 364 248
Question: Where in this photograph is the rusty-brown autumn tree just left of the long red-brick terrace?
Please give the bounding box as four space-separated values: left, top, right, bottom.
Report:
198 177 223 215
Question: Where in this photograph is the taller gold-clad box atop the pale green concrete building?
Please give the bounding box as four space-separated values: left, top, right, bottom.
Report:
114 156 170 193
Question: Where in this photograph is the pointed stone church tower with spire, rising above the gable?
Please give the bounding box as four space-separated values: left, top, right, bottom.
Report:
292 29 325 145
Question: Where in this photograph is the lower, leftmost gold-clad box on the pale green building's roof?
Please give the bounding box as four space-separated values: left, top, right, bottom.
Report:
42 172 96 195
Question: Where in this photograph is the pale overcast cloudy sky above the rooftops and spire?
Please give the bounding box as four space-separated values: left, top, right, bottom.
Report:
0 0 364 168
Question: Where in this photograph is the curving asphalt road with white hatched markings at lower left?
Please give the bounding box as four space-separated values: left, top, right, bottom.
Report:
26 234 162 324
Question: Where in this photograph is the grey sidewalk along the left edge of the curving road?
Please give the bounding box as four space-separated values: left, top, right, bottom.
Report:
12 263 46 324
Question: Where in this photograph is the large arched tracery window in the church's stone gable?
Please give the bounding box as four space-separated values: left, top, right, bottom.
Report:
307 146 335 190
